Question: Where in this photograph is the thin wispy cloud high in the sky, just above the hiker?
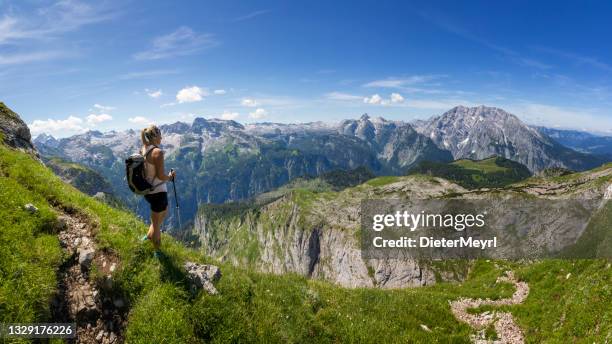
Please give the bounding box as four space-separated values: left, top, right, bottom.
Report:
133 26 217 60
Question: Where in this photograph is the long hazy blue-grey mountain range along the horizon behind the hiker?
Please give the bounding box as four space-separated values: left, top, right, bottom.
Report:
34 106 606 228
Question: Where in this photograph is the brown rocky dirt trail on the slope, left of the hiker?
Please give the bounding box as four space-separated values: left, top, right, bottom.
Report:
52 212 127 344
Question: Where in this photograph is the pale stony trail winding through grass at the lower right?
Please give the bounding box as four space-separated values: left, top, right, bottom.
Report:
450 271 529 344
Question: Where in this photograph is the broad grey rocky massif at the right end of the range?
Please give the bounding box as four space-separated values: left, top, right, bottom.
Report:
418 106 603 172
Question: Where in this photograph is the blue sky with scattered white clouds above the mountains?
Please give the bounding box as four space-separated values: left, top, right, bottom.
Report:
0 0 612 136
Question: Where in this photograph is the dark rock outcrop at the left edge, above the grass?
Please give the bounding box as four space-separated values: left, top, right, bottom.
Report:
0 102 38 157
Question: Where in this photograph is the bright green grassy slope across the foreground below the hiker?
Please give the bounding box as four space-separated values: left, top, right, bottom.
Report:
0 145 612 343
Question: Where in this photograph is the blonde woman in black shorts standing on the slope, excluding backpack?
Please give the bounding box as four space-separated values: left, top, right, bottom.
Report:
140 125 176 258
